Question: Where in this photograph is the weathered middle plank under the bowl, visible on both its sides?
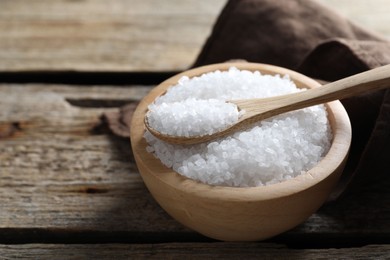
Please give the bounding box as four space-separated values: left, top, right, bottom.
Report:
0 84 390 246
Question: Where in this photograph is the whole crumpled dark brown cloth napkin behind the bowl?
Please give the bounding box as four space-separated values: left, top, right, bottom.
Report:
103 0 390 199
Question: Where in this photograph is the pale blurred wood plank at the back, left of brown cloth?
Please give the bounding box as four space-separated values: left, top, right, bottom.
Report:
0 0 226 71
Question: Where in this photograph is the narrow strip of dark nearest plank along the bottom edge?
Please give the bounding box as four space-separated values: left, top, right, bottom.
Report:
0 243 390 259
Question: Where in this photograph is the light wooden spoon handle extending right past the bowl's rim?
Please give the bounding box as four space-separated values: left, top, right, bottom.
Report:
236 65 390 120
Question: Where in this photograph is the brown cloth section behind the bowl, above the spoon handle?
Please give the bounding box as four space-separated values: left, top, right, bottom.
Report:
194 0 389 75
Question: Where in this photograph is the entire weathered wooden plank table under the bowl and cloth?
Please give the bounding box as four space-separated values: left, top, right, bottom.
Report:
0 0 390 259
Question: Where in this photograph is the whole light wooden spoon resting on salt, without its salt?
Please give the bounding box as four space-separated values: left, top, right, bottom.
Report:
144 65 390 144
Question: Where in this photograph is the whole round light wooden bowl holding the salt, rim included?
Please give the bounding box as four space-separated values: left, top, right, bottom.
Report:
130 63 351 241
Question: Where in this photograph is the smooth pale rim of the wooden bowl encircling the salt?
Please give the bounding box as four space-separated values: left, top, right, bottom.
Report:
130 62 352 202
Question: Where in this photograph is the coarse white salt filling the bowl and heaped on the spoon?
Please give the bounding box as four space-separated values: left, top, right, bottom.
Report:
144 68 331 187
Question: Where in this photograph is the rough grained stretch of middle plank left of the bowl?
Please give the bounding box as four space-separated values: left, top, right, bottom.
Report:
0 85 183 236
